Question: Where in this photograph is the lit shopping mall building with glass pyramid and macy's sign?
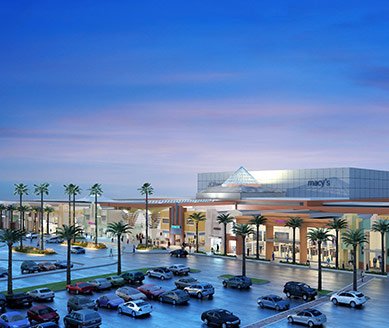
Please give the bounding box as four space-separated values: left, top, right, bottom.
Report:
2 167 389 271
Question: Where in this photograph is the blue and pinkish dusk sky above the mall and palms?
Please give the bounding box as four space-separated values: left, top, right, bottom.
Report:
0 0 389 199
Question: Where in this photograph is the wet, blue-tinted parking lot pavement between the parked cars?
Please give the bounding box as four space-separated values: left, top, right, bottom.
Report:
0 245 389 327
